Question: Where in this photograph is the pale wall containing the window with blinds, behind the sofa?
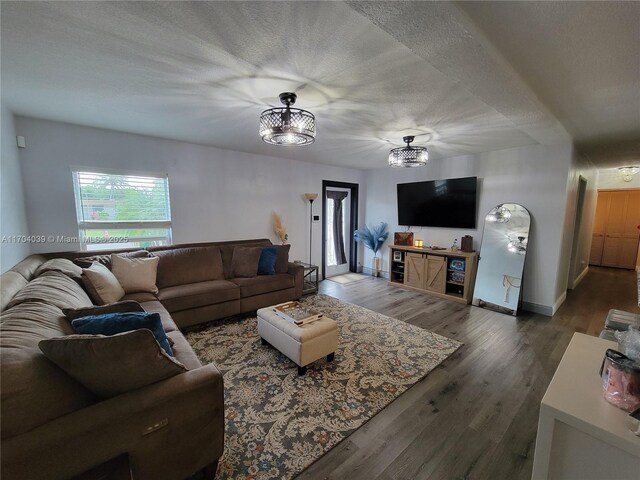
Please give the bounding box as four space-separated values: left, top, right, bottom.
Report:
16 117 366 263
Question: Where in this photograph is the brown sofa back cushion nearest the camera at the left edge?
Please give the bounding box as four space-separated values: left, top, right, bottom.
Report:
0 302 95 438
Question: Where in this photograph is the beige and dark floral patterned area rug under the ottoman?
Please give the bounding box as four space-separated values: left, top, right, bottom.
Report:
186 295 462 479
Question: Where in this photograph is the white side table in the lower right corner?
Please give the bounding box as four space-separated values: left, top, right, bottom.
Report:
532 333 640 480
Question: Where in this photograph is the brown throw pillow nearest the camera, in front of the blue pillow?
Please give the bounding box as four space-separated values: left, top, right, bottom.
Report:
39 329 187 398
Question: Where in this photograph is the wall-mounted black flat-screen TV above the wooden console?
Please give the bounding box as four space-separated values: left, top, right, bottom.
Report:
398 177 478 228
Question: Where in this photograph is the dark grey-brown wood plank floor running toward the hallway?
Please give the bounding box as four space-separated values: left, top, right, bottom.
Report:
298 267 638 480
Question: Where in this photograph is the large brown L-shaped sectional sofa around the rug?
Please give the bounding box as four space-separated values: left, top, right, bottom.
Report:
0 239 303 480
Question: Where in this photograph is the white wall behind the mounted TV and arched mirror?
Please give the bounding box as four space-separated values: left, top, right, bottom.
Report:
363 144 572 314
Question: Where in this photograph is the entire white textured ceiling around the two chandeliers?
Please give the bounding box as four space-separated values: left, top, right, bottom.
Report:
0 1 640 168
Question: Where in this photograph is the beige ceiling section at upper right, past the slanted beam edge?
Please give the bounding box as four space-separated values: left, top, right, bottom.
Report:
456 1 640 169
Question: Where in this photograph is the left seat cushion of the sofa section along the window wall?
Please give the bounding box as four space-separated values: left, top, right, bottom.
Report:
158 280 240 312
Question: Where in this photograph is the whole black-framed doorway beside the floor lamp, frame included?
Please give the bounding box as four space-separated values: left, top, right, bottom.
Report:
322 180 358 279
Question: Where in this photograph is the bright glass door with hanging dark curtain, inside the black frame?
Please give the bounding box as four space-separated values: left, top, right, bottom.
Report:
324 187 353 278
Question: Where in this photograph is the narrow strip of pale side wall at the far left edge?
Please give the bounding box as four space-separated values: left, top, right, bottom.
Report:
0 105 30 272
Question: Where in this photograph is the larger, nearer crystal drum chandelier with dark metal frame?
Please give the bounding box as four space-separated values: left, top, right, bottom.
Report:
260 92 316 146
